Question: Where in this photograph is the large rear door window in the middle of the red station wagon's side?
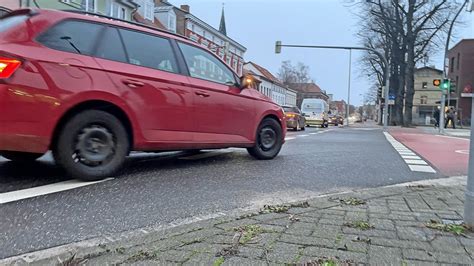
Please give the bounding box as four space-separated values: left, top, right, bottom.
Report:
120 29 179 73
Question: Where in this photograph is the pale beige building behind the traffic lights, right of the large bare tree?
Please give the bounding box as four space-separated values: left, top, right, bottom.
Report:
412 67 443 125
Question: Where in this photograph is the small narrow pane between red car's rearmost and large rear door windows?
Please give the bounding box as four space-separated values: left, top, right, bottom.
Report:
95 27 127 63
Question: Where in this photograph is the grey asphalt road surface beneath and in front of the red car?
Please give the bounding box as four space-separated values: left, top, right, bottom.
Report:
0 124 442 258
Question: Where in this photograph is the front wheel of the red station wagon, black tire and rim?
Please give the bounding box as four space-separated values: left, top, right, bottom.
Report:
247 118 283 160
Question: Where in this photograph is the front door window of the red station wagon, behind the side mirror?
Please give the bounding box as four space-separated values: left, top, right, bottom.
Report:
178 42 236 84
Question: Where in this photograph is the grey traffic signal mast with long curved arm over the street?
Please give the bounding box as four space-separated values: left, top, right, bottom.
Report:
275 41 390 131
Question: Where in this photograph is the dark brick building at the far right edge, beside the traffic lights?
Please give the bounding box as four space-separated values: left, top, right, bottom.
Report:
448 39 474 124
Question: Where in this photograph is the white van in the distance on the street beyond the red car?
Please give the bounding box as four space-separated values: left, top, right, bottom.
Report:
301 99 329 127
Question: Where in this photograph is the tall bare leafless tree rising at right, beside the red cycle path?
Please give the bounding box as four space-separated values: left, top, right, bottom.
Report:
359 0 453 126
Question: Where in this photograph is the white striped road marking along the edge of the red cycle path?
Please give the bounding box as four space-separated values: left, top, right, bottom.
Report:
383 132 436 173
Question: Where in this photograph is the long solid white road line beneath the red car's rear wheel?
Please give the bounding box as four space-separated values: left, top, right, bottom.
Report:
0 178 114 204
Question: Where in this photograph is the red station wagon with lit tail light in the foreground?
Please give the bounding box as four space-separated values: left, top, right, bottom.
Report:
0 9 286 180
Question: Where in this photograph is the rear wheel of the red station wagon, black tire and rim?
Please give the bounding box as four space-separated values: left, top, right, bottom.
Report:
53 110 130 181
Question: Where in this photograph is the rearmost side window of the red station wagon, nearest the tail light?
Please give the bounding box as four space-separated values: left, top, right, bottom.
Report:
37 20 104 55
